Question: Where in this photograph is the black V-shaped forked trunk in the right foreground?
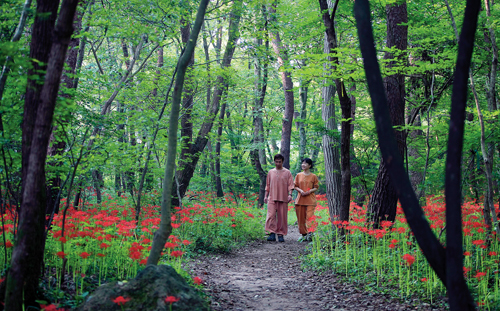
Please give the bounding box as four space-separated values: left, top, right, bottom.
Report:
354 0 480 310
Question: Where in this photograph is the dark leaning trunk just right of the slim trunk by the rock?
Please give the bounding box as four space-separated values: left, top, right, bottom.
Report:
172 1 242 206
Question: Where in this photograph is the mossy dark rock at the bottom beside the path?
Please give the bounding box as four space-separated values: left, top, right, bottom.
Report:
77 265 209 311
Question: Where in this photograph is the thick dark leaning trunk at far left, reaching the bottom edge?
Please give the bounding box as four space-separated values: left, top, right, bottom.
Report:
5 0 78 311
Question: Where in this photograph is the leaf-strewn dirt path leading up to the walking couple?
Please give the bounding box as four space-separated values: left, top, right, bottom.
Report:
188 226 445 311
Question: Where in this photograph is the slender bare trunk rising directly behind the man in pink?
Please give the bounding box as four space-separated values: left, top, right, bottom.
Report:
269 0 294 169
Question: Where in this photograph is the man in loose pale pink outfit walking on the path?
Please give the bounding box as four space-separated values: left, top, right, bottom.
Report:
264 153 294 242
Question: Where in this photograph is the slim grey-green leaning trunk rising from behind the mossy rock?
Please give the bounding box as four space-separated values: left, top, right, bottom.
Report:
147 0 208 265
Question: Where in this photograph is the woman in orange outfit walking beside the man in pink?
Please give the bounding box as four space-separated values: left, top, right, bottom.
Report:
294 158 319 242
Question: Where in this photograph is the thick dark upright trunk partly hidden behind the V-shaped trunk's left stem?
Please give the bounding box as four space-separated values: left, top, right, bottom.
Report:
368 1 408 226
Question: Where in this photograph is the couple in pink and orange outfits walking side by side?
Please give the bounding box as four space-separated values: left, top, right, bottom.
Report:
264 154 319 242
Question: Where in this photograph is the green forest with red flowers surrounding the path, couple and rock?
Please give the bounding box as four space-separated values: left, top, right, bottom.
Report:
0 0 500 310
